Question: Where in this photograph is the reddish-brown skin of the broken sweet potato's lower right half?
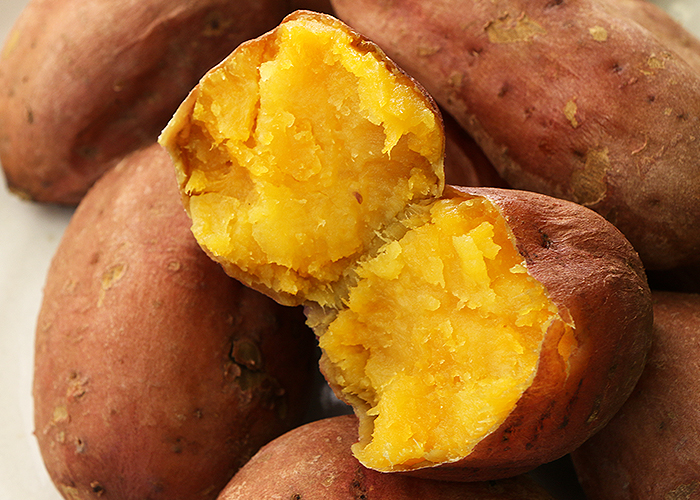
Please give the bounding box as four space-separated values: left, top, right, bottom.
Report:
321 187 652 481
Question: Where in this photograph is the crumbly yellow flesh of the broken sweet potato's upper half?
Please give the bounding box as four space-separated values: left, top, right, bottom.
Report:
172 16 444 303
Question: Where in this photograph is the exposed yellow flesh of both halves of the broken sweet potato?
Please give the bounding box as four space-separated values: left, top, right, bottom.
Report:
161 11 560 470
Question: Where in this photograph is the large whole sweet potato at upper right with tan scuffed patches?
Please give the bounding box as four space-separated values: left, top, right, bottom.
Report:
333 0 700 269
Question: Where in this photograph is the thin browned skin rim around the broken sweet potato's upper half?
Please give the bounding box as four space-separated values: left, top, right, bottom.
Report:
158 10 445 306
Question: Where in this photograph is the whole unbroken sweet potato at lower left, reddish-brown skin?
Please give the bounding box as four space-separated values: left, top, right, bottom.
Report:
33 145 316 500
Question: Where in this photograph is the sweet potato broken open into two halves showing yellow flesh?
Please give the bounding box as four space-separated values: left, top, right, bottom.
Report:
160 12 651 480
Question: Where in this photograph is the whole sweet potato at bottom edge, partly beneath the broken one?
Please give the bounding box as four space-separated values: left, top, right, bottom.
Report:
218 415 552 500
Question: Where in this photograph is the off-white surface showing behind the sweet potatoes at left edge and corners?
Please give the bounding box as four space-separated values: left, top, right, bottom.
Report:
0 0 700 500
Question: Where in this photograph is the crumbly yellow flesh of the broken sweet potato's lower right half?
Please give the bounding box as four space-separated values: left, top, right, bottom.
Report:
320 198 558 470
